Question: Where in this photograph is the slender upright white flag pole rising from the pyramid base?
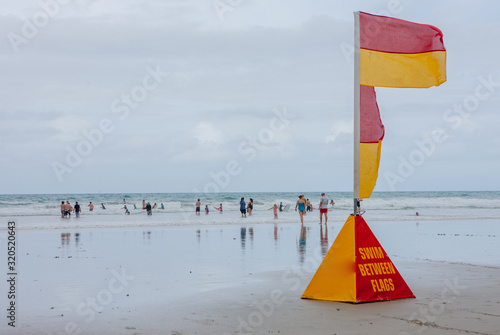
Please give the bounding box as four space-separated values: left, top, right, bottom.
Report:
353 12 360 215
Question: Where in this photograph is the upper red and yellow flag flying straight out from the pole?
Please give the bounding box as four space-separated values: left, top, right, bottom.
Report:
359 12 446 88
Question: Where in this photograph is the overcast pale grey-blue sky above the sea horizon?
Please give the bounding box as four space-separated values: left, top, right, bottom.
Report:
0 0 500 194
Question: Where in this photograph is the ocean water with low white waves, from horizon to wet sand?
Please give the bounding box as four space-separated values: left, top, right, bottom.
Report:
0 191 500 229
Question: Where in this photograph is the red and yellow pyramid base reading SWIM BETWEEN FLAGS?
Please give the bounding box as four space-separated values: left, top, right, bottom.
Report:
302 216 415 303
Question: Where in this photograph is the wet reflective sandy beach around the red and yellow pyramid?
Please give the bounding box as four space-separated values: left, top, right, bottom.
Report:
0 218 500 334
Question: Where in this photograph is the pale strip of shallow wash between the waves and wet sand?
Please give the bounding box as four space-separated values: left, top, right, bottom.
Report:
0 210 500 231
